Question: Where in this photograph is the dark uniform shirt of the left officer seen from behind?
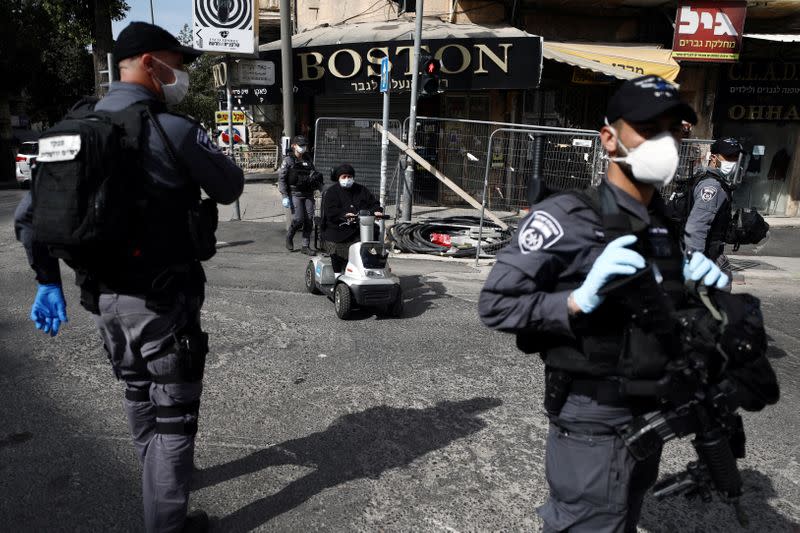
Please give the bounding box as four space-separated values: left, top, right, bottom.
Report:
14 82 244 283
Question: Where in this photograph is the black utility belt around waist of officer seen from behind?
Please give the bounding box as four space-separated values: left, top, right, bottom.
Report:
75 261 206 315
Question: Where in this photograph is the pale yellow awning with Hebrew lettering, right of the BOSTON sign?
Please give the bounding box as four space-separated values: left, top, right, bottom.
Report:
543 41 680 81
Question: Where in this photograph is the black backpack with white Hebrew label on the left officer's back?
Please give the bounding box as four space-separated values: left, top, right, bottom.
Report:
32 101 150 262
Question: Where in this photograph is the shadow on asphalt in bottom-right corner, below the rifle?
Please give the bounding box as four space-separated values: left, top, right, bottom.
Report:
639 469 800 533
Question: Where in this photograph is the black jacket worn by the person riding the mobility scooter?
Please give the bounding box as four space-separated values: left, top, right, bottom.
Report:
322 183 381 242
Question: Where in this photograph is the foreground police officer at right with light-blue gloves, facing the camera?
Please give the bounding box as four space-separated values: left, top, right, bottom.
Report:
479 76 727 532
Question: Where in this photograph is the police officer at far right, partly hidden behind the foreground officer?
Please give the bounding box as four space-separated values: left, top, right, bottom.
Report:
684 138 744 291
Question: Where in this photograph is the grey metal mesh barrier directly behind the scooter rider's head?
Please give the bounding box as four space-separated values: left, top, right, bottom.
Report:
314 117 401 204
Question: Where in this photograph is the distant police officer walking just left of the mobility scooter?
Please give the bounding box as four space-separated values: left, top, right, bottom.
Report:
278 135 322 255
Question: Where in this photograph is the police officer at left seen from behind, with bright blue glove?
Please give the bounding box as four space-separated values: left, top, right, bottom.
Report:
15 22 244 532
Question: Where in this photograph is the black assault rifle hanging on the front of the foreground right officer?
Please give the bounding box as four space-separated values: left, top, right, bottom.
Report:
602 266 763 526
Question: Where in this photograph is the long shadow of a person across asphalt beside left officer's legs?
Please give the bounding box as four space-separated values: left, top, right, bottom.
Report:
197 398 502 531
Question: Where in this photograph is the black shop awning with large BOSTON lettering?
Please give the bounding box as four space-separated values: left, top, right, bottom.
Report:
250 20 542 134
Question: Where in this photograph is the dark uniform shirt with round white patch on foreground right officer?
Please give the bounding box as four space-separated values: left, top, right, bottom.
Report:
478 181 667 337
